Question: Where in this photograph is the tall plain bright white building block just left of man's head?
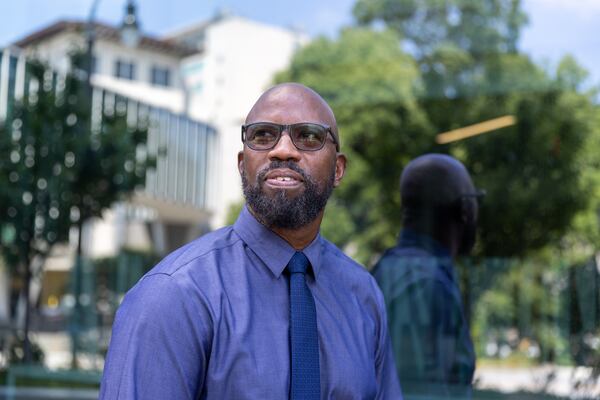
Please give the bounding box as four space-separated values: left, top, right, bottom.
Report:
166 16 307 227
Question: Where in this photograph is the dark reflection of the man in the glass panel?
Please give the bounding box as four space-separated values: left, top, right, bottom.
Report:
373 154 482 398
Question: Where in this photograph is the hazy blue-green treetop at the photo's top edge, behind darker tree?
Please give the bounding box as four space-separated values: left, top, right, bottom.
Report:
354 0 527 97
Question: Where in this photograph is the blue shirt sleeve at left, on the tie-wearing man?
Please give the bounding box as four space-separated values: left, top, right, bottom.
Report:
100 273 212 400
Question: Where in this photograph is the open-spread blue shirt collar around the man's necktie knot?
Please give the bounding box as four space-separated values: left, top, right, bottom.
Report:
233 206 322 279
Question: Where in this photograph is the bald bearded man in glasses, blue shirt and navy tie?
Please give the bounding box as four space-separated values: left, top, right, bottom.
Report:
100 83 401 400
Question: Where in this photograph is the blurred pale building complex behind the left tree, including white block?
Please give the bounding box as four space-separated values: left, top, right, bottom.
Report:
0 7 308 312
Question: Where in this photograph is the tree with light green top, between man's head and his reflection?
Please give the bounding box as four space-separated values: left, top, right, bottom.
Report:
277 28 434 263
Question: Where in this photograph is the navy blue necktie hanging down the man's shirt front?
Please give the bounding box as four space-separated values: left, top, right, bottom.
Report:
288 252 321 400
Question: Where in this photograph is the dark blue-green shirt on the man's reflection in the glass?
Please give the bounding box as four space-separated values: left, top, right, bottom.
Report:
373 229 475 399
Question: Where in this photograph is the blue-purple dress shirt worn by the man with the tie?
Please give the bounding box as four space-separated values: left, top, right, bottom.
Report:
100 208 402 400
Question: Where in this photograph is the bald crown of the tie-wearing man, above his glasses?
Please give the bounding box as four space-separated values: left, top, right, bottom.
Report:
246 82 340 150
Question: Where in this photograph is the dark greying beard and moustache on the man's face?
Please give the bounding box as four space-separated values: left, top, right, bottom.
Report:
242 161 335 229
